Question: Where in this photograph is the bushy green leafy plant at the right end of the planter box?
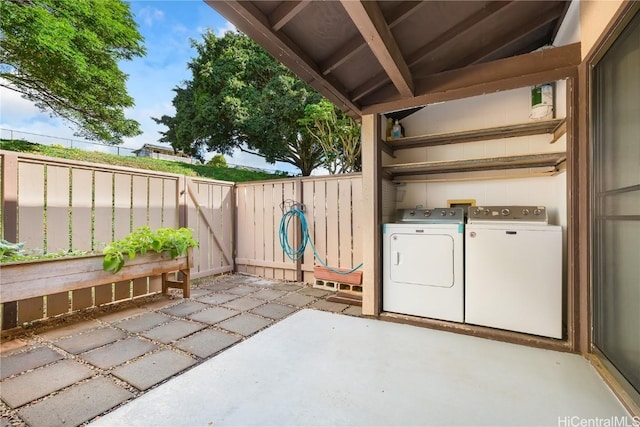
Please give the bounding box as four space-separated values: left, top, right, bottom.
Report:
102 226 198 273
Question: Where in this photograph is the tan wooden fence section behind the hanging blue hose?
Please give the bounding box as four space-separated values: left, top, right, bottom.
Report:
236 174 362 283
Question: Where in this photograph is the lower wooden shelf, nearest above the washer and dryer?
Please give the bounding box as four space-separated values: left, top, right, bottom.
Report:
383 151 567 178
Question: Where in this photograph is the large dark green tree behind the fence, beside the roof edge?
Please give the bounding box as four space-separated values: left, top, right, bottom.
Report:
154 32 323 175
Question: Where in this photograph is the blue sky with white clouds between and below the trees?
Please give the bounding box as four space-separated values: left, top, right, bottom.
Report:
0 0 297 172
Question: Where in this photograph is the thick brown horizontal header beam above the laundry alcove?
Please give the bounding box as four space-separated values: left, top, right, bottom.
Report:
362 43 582 114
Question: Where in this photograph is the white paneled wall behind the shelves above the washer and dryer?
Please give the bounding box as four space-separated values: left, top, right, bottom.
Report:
383 81 567 231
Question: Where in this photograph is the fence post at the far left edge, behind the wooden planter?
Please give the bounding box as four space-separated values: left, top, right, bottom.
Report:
2 152 18 330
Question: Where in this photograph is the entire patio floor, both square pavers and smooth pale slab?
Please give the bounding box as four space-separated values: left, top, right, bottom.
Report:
0 275 633 427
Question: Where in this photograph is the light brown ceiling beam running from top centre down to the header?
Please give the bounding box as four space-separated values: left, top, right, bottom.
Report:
341 0 413 97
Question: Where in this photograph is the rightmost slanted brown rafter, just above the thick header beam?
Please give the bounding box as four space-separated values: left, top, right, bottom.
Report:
444 4 559 73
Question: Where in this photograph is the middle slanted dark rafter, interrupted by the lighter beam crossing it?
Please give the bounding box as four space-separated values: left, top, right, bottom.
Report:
351 1 515 101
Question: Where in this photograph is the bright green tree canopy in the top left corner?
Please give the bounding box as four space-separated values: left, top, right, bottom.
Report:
0 0 145 144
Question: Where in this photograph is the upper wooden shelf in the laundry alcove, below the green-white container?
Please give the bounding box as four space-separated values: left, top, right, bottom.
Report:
385 118 566 151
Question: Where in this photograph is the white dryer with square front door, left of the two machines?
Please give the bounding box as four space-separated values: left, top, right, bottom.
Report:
382 208 464 322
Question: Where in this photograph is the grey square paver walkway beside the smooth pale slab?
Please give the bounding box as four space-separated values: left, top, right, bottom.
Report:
0 275 361 427
